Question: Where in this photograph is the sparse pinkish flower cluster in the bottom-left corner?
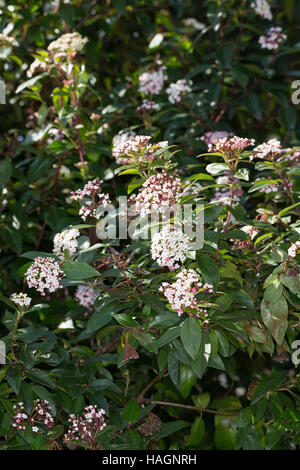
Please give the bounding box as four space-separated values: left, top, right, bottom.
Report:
11 399 54 432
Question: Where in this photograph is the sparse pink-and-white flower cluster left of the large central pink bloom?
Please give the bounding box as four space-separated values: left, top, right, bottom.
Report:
72 179 110 220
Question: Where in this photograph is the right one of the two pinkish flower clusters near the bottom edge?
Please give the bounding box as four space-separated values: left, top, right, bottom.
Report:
64 405 106 447
